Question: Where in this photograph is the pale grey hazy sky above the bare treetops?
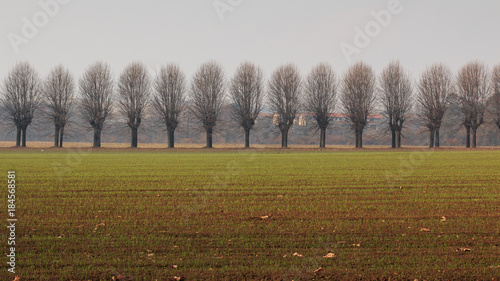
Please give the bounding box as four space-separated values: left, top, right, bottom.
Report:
0 0 500 79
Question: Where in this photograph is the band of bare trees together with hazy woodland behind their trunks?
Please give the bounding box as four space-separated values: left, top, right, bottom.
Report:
0 58 500 148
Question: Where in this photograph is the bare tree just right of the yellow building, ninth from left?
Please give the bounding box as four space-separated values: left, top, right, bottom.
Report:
304 63 337 148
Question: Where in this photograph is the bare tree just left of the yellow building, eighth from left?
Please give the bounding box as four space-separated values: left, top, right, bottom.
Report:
268 64 302 148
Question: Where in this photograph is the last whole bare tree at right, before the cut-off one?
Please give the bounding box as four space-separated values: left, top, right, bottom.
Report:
457 61 491 147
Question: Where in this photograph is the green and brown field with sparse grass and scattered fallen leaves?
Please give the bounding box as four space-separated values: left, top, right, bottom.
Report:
0 149 500 280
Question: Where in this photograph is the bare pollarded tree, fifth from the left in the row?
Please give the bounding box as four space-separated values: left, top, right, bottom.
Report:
153 64 186 148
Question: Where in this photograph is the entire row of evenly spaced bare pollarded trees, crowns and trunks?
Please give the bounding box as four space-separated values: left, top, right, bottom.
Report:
0 61 500 148
